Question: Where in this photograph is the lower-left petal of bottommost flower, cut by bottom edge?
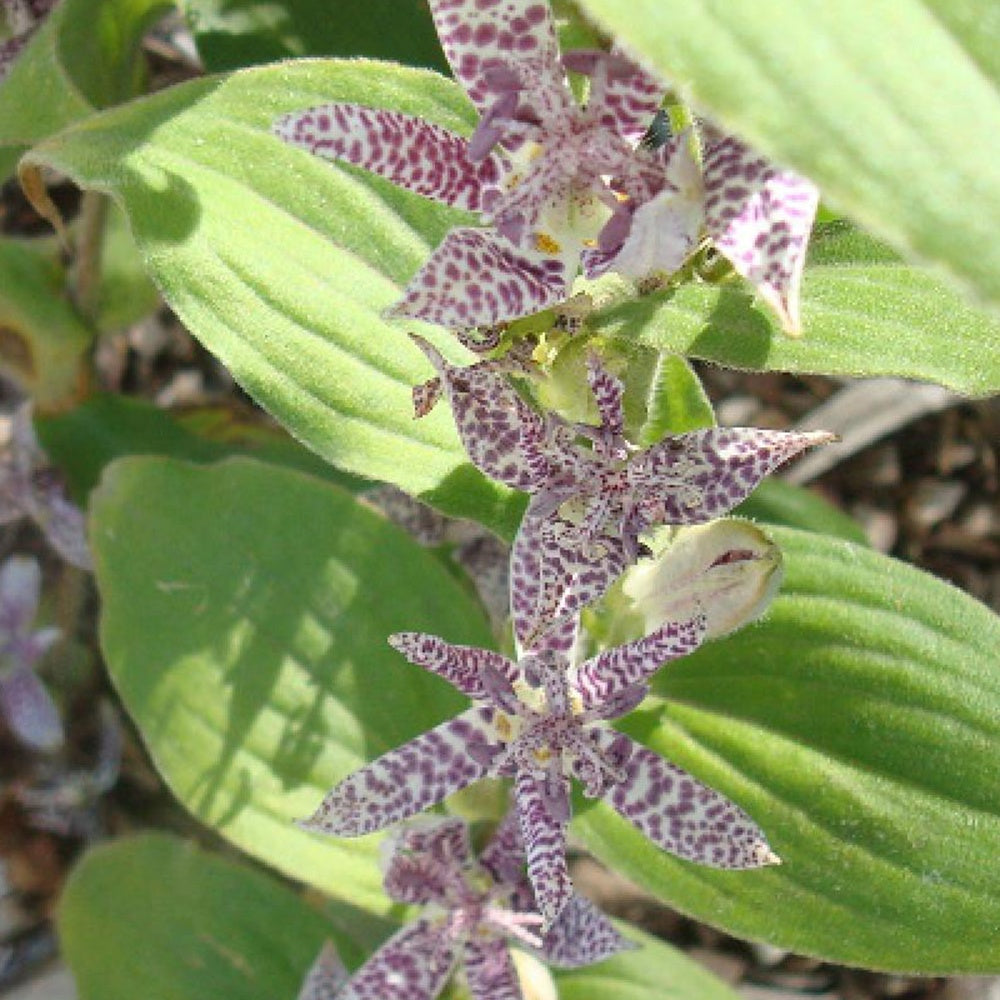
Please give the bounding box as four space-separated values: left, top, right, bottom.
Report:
337 918 460 1000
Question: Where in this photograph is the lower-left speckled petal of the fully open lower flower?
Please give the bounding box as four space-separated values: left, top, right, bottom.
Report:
299 708 493 837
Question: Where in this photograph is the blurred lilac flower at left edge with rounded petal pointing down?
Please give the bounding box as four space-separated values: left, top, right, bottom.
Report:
0 556 63 750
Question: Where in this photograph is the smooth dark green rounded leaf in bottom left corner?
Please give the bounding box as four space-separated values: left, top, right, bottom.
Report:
59 834 352 1000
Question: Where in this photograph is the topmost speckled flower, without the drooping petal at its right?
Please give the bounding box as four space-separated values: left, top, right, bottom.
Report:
274 0 700 328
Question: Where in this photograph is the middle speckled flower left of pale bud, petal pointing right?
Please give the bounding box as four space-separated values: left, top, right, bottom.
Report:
413 337 833 652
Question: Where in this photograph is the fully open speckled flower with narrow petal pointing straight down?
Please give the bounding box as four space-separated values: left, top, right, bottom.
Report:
303 611 777 924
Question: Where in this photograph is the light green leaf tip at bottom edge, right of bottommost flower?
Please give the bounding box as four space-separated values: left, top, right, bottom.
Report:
555 926 736 1000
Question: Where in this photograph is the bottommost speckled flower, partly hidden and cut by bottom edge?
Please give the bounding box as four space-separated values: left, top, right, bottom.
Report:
299 811 632 1000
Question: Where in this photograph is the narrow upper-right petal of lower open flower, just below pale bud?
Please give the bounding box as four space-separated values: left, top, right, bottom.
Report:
573 614 708 708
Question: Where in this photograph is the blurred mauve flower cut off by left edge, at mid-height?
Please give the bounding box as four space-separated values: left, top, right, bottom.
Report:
0 403 93 570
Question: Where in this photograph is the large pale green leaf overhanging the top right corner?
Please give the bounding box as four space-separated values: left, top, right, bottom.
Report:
582 0 1000 316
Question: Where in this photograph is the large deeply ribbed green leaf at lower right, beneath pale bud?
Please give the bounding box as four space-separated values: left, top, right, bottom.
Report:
575 528 1000 975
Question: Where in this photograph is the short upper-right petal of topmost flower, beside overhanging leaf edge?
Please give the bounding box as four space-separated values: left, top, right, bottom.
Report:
563 46 667 143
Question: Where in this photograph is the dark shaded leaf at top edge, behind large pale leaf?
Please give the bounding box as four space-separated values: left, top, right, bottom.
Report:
183 0 448 72
